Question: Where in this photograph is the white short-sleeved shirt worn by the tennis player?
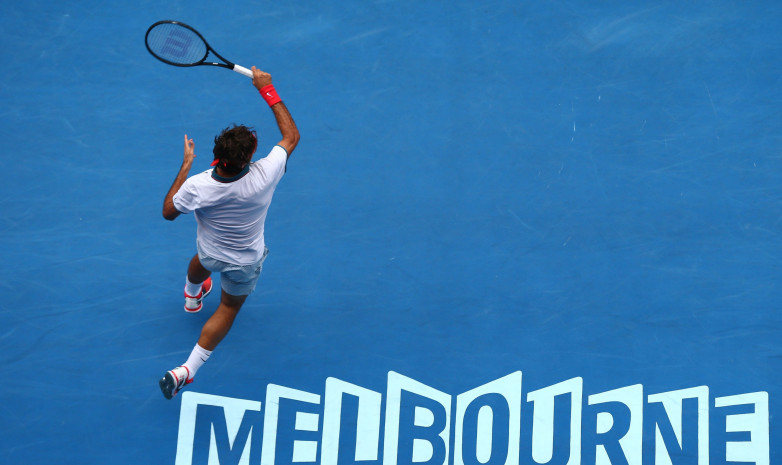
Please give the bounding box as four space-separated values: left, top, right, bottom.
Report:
174 145 288 265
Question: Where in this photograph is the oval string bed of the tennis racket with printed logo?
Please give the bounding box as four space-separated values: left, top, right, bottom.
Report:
147 23 209 65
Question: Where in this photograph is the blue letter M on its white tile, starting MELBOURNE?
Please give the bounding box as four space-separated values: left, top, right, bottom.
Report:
176 392 262 465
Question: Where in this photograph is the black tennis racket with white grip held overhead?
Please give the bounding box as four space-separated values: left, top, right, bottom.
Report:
144 20 253 78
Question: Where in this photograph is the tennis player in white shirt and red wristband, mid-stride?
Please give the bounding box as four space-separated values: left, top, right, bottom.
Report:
160 66 299 399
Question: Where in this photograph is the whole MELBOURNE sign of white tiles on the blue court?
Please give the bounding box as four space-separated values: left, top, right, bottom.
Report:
176 371 770 465
